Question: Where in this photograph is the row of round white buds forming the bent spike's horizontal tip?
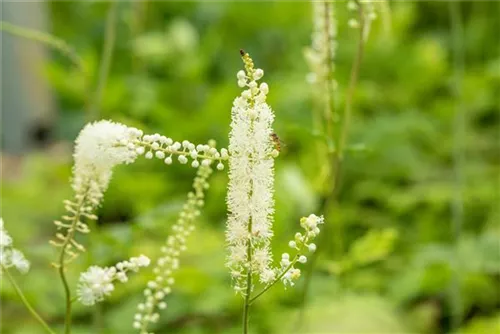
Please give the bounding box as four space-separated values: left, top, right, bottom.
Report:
134 133 229 170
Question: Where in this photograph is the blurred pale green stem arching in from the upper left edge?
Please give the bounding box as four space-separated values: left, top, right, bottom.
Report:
0 21 85 73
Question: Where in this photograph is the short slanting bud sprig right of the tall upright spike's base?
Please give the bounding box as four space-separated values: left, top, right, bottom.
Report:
278 214 324 286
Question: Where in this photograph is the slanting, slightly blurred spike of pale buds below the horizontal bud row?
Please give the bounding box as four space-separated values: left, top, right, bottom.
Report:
132 164 212 334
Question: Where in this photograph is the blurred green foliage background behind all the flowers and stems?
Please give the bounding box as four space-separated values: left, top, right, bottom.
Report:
1 0 500 334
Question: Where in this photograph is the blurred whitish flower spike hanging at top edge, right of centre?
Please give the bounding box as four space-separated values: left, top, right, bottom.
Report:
305 1 338 86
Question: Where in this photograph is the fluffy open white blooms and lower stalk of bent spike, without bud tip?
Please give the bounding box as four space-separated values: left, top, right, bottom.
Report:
51 121 142 267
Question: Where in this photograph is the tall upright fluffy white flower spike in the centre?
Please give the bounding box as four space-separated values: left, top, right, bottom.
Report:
226 52 279 295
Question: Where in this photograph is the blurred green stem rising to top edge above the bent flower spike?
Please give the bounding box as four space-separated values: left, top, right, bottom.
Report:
88 0 118 120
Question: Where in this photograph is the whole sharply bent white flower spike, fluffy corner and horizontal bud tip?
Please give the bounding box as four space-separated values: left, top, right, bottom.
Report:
51 120 228 267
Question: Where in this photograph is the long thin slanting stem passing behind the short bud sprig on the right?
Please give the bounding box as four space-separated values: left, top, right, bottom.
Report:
297 1 365 328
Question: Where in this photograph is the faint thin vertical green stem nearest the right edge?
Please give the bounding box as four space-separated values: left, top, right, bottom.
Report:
449 1 466 330
